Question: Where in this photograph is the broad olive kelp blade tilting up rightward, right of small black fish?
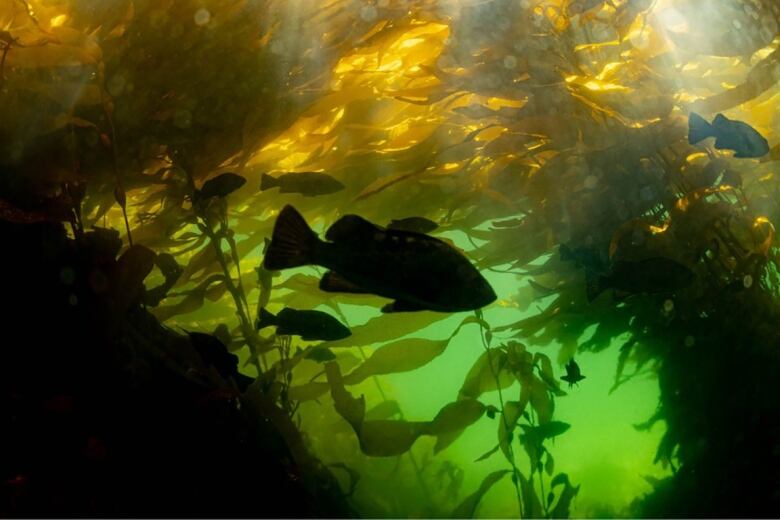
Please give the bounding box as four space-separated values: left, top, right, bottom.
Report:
344 338 449 385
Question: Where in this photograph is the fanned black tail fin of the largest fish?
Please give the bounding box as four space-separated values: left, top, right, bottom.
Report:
263 205 319 271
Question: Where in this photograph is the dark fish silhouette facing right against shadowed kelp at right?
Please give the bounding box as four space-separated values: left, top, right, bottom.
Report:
587 257 694 301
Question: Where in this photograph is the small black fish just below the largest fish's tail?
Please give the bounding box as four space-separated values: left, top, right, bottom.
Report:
255 308 352 341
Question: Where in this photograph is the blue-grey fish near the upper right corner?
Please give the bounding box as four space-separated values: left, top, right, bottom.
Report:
688 112 769 159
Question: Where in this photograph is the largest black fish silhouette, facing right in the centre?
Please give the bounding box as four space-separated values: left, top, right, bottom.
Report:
264 206 496 312
